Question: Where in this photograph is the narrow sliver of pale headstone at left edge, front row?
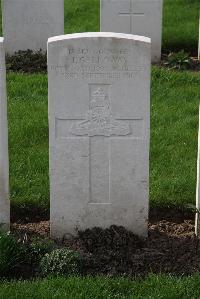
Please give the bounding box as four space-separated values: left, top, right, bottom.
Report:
0 37 10 230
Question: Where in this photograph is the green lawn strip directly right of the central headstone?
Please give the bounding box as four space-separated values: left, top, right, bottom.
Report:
150 69 200 206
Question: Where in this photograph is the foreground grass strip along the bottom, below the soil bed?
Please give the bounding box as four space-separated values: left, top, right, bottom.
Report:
0 275 200 299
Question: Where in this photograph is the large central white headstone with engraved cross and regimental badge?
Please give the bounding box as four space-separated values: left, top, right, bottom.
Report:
48 33 151 237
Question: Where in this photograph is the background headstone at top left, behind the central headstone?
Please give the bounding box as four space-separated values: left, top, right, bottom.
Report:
2 0 64 54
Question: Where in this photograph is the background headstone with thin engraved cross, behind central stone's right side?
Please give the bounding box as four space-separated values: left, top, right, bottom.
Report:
100 0 163 62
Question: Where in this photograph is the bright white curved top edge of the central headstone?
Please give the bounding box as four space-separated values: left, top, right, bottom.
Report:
48 32 151 45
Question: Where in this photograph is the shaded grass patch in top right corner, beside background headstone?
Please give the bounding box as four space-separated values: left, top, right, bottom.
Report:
163 0 200 55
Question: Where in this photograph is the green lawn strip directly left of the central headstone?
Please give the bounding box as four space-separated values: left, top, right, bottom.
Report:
8 73 49 211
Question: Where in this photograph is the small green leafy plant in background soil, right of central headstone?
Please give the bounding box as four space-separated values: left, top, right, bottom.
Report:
164 50 193 70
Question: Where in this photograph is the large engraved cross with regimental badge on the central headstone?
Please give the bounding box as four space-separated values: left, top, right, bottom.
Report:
56 84 143 204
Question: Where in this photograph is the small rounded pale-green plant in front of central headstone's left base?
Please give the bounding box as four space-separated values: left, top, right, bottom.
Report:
40 248 83 276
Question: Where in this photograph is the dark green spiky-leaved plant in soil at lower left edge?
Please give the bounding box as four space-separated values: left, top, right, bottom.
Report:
0 233 25 277
